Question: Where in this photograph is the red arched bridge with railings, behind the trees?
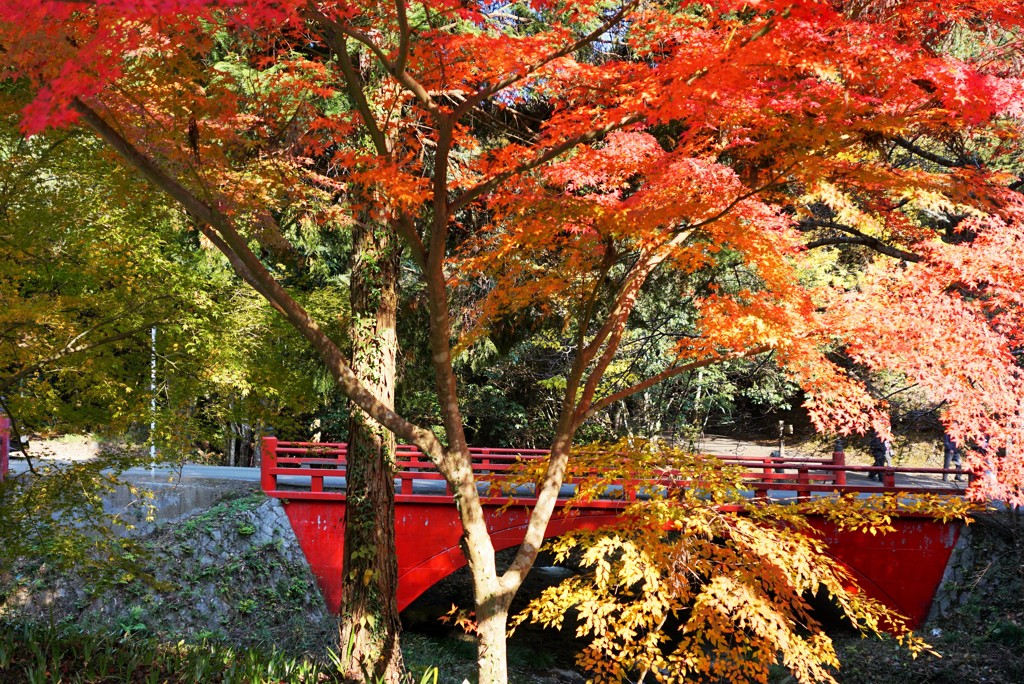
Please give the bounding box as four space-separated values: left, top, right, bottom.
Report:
261 437 962 626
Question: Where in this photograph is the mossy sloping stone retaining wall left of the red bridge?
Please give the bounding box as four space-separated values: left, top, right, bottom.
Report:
0 493 337 651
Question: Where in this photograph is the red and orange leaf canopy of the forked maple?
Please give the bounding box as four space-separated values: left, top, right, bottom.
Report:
0 0 1024 496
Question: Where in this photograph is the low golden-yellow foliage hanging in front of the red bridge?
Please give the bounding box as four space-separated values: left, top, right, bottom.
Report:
513 439 972 683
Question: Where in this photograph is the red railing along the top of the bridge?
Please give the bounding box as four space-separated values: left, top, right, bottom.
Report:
260 437 964 507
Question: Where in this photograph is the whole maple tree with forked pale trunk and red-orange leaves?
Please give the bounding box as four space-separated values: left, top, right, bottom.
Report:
0 0 1024 681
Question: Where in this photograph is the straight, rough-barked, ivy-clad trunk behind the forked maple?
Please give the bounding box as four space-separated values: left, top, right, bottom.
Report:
341 216 404 684
